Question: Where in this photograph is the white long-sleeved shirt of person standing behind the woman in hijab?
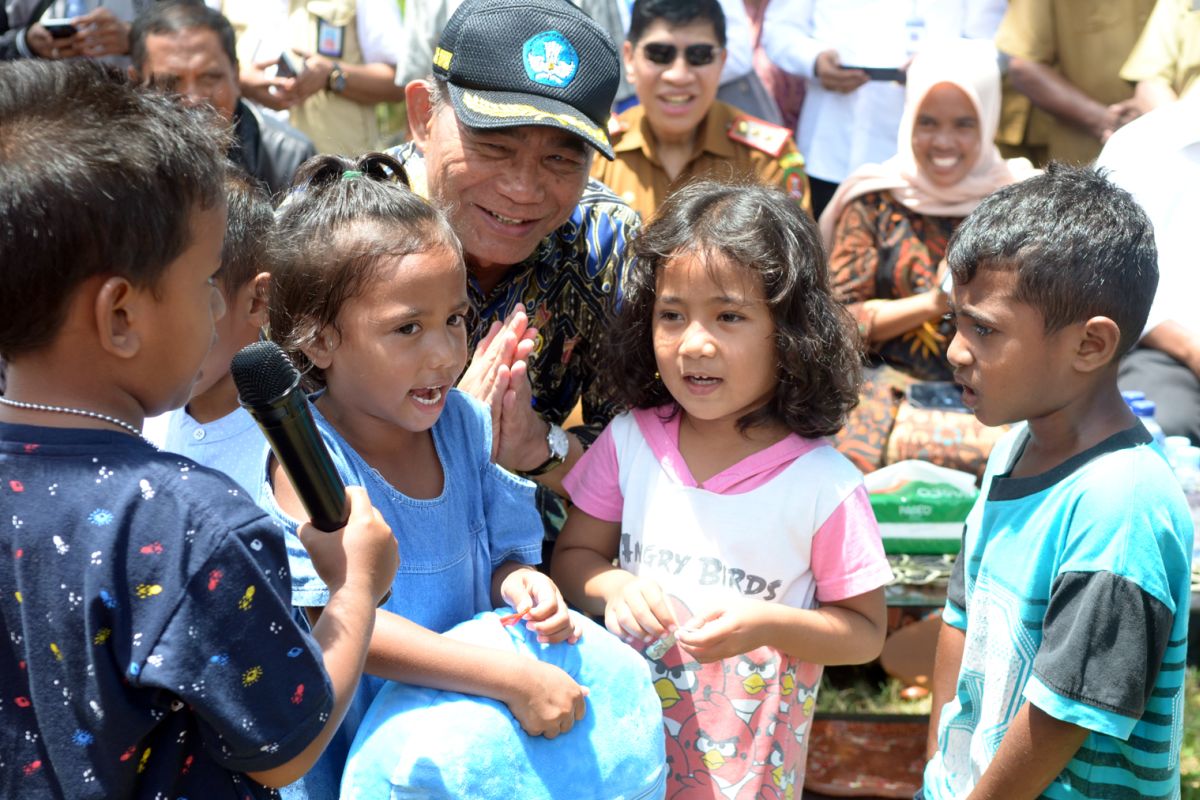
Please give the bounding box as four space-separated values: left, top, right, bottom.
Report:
762 0 1007 184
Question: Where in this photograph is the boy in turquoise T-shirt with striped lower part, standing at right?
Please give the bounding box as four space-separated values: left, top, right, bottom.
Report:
918 164 1193 800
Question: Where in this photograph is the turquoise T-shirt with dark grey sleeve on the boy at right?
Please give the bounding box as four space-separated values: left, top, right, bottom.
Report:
925 423 1192 800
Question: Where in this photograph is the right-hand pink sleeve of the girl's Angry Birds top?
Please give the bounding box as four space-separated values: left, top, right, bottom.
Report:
812 486 893 602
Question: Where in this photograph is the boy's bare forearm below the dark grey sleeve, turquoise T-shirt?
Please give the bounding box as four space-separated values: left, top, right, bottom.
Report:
968 702 1091 800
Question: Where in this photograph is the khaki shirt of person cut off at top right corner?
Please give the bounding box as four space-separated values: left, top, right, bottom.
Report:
1121 0 1200 96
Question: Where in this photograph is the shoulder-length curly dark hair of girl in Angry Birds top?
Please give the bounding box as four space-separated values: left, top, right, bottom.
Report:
605 181 862 438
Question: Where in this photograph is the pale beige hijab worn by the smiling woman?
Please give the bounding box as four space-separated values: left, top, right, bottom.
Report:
820 40 1038 241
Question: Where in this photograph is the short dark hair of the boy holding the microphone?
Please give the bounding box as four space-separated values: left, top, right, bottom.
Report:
0 59 228 359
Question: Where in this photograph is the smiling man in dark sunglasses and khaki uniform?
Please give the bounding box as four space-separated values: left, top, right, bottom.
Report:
592 0 811 219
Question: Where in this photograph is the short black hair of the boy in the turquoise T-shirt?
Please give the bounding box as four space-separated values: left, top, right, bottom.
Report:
946 163 1158 357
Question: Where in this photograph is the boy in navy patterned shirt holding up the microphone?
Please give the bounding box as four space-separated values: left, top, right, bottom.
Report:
0 61 396 799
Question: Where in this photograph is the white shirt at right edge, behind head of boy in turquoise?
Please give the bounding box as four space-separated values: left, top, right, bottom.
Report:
1096 92 1200 336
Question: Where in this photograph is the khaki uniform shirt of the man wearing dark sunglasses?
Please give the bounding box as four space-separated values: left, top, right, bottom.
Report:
592 101 812 219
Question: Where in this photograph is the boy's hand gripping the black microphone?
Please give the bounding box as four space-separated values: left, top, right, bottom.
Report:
296 486 400 603
